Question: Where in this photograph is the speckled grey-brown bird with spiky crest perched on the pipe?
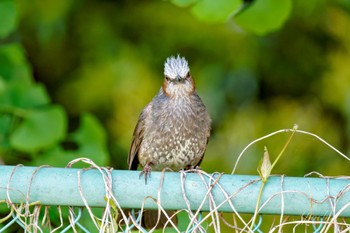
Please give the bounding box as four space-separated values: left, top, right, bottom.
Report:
128 55 211 229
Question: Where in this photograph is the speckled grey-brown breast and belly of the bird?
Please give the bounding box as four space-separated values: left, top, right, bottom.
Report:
139 96 210 170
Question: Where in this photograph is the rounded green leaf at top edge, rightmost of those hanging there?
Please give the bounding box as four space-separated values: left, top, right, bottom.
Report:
235 0 292 35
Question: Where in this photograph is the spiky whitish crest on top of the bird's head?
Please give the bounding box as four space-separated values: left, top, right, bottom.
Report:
164 55 190 79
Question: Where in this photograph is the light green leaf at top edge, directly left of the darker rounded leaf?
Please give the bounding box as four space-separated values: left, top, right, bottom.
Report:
192 0 242 23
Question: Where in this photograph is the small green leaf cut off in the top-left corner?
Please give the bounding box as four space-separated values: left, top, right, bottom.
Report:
0 0 17 38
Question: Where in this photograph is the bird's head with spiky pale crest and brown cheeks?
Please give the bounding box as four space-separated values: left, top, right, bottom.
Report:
163 55 195 98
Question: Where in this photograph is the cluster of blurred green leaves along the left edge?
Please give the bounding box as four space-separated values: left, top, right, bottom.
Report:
0 1 108 166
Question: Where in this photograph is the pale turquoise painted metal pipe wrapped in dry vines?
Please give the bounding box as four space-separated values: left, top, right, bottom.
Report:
0 166 350 217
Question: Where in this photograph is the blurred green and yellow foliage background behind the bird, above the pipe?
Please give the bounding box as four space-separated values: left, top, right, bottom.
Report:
0 0 350 175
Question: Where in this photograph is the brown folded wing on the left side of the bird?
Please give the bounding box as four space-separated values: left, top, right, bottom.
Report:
128 104 150 170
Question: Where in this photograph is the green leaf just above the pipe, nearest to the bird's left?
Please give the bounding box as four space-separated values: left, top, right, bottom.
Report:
72 113 109 165
